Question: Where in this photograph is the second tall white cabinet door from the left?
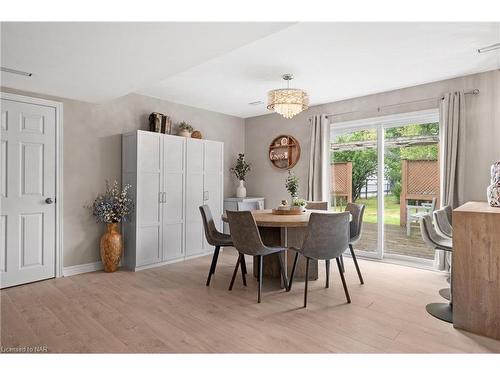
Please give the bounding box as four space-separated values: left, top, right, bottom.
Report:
162 135 185 261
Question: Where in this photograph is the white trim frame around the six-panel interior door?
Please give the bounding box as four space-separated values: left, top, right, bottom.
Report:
0 91 64 278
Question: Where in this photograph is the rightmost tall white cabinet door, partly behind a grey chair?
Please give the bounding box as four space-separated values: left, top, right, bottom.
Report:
203 141 223 251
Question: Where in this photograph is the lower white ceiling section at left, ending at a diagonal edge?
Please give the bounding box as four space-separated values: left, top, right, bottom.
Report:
0 22 290 102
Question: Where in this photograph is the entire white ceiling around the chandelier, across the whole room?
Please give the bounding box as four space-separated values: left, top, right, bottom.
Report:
2 23 500 117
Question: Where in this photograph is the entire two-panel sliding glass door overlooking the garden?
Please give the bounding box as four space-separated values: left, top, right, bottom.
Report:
330 110 440 266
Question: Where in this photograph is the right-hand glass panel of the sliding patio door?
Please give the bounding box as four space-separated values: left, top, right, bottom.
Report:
384 122 440 261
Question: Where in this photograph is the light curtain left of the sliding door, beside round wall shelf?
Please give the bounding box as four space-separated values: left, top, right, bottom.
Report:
307 115 330 201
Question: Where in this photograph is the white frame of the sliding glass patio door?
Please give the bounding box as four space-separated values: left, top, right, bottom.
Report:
328 108 443 268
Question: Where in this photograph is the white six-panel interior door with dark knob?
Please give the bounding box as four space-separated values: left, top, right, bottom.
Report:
0 98 56 287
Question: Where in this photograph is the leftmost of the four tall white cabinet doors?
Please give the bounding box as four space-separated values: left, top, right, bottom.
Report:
136 132 163 267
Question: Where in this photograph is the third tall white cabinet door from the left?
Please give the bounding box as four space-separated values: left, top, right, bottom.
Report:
185 139 204 256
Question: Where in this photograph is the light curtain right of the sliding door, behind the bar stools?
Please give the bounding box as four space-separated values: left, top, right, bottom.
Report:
436 91 465 270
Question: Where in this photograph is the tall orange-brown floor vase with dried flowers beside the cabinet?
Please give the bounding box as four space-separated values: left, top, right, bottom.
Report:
88 181 134 272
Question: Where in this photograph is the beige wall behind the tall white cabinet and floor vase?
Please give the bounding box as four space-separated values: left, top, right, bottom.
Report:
1 88 245 267
